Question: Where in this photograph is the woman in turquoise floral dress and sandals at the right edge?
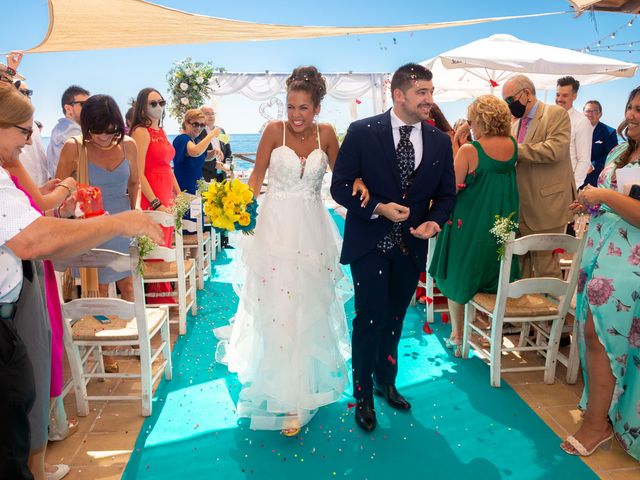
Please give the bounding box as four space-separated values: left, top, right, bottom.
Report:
561 87 640 460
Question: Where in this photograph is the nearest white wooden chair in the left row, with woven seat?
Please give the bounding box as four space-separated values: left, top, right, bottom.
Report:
56 248 172 416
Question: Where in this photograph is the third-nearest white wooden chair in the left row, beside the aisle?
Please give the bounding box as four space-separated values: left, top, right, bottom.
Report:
182 195 215 290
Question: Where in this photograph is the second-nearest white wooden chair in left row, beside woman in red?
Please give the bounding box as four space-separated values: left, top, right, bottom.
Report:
143 210 198 335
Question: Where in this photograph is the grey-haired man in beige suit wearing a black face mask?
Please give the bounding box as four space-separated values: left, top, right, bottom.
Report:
502 75 576 277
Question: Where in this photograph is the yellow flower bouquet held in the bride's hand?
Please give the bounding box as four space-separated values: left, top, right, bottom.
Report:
202 179 258 234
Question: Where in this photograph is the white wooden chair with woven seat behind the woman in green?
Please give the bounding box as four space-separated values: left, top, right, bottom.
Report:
462 233 585 387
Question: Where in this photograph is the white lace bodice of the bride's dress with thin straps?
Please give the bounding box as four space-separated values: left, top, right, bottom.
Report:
267 124 329 201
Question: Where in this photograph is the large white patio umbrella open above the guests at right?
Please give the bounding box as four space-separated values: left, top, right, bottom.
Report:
422 34 638 102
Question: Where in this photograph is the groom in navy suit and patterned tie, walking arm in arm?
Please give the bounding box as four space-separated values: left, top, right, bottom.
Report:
331 63 456 432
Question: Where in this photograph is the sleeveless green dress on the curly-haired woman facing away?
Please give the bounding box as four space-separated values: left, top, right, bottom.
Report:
429 138 518 304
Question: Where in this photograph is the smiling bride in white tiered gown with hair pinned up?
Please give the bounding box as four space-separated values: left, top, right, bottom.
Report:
216 67 369 436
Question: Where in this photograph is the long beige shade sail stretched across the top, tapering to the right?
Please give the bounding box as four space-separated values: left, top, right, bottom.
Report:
29 0 565 53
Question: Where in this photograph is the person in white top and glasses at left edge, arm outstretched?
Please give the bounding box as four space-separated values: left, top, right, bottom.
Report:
0 76 162 480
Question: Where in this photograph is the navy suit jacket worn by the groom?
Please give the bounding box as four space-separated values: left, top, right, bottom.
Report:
331 111 456 271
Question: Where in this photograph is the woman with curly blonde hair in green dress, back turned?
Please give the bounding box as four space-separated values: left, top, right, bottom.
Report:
429 95 518 356
